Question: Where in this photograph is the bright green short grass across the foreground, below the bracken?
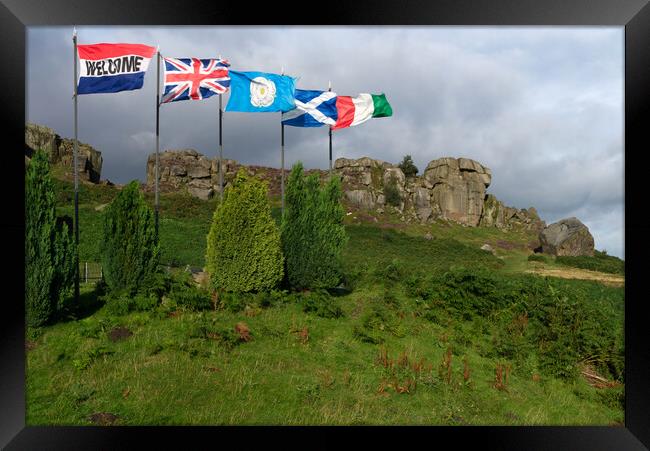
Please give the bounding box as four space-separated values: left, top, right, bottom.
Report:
27 278 623 425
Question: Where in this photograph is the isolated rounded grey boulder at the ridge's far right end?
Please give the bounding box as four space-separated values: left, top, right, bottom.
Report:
539 218 594 257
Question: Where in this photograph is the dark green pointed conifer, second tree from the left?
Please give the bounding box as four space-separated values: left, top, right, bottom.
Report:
100 180 160 294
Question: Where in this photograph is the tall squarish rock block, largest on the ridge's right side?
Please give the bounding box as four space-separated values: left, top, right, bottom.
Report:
424 157 492 226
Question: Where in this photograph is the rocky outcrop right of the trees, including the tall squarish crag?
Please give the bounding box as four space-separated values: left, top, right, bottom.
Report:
334 157 545 231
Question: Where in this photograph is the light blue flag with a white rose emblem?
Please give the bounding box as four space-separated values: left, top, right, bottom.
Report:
226 70 296 113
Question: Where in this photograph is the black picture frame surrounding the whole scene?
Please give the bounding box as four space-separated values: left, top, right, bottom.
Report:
0 0 650 450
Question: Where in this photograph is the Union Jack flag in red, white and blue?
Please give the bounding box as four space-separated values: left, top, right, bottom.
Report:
161 58 230 103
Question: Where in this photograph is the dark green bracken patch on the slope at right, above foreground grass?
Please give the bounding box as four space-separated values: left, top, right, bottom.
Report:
406 268 624 380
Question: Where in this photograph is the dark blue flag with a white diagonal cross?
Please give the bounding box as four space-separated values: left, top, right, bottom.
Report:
282 89 338 127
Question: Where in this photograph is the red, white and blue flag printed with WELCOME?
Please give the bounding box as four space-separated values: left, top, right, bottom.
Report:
77 44 156 94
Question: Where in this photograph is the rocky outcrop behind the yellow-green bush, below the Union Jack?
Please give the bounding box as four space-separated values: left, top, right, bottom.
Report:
146 149 327 200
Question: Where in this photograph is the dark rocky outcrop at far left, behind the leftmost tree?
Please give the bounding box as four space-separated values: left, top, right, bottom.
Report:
25 124 102 183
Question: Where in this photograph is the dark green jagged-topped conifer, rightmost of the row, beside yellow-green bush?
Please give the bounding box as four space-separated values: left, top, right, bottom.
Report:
281 162 347 289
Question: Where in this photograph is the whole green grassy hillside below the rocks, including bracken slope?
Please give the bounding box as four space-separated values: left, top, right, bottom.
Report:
27 178 624 425
